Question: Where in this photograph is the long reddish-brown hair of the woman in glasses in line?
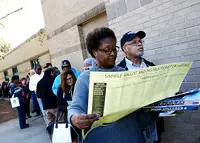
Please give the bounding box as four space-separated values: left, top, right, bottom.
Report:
61 69 76 93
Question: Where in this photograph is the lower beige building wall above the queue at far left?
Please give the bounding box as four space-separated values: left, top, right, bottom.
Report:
0 33 51 82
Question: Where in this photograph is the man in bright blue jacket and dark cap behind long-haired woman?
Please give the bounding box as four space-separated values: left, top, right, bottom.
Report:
52 60 80 96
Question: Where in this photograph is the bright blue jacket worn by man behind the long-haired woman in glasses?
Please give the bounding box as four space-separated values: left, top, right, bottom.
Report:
52 68 81 96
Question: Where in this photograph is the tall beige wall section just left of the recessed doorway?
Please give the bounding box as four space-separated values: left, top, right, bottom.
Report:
41 0 105 71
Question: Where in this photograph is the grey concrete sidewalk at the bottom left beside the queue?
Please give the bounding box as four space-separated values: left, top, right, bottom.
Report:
0 117 50 143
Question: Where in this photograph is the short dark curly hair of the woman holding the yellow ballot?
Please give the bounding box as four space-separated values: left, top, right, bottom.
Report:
86 27 117 57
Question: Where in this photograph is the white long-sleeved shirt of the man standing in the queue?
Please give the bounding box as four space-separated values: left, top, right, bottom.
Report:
29 72 44 92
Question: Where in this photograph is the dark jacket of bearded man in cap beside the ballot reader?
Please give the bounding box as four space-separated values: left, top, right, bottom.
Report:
118 58 164 139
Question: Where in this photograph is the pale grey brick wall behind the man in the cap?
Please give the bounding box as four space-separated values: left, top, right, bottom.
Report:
105 0 200 143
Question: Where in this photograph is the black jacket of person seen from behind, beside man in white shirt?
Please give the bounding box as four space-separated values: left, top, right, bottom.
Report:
37 74 57 110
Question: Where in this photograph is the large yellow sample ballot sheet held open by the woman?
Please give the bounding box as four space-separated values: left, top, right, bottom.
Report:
88 62 192 132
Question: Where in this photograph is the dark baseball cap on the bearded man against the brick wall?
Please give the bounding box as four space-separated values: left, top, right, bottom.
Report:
120 31 146 50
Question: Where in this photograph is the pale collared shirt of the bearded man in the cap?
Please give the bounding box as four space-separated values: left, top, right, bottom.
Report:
125 58 147 70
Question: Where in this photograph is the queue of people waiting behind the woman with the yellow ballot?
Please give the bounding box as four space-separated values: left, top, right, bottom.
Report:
10 58 94 129
